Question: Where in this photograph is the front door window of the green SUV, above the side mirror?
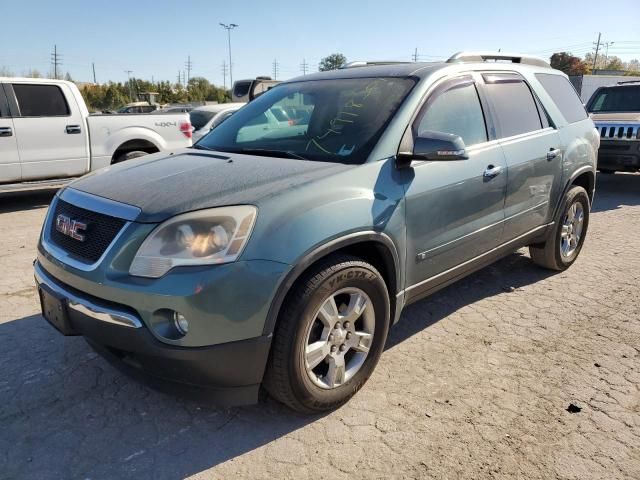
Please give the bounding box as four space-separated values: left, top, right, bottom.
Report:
417 82 487 146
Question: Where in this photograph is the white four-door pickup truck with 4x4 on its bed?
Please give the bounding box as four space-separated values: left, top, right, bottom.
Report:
0 77 192 192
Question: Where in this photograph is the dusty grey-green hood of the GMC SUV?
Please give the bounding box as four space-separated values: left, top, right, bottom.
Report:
70 149 354 222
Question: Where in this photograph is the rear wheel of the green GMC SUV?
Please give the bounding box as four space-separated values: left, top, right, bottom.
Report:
529 186 591 270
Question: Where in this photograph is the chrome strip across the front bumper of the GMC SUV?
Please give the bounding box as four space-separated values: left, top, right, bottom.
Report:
34 262 142 328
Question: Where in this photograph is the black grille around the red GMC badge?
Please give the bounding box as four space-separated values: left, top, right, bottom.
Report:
48 199 126 263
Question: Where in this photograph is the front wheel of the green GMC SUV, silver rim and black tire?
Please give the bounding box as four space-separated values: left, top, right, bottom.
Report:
265 255 390 413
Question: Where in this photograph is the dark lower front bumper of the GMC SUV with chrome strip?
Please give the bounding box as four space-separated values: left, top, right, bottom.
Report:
34 262 271 405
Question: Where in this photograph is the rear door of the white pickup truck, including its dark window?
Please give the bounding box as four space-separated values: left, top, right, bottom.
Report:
7 82 89 181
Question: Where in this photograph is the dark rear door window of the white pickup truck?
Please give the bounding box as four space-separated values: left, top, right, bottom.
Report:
13 83 69 117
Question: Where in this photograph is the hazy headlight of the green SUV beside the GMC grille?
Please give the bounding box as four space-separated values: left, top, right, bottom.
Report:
129 205 257 278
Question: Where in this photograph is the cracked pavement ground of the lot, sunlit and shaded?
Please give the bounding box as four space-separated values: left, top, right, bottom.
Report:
0 175 640 479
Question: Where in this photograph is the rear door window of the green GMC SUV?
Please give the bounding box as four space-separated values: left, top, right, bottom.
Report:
486 80 542 138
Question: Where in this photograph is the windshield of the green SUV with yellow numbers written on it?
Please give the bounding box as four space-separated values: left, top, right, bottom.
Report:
199 78 415 163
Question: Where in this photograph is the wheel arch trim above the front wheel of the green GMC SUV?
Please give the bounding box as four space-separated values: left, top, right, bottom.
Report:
263 231 401 335
